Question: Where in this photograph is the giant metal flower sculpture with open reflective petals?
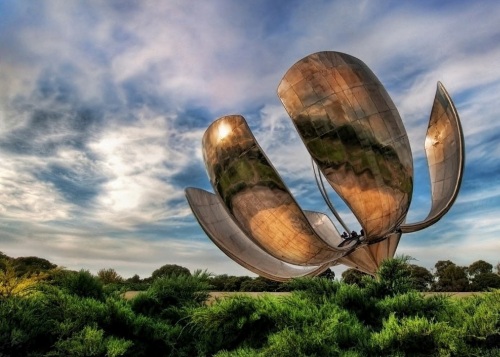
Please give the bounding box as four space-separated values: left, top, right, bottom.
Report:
186 52 464 281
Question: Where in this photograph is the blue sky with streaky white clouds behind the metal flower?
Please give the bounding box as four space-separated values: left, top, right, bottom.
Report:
0 0 500 278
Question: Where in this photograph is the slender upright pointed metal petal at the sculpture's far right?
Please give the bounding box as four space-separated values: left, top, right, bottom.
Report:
401 82 465 233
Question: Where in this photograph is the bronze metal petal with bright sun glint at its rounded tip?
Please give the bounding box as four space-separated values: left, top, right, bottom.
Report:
203 115 343 265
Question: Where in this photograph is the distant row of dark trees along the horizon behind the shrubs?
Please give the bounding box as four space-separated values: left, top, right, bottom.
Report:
0 252 500 295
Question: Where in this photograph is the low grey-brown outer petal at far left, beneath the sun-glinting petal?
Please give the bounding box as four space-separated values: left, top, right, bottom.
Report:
185 187 330 281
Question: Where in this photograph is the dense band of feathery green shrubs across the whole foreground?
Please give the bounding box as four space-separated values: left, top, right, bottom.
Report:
0 252 500 357
